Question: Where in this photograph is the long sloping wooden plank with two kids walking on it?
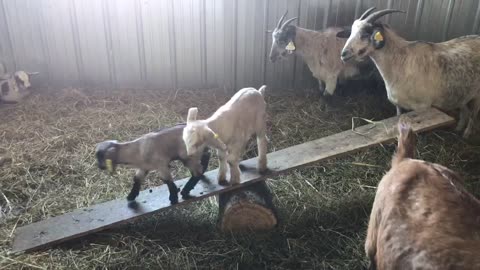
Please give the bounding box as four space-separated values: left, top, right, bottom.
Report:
12 109 454 253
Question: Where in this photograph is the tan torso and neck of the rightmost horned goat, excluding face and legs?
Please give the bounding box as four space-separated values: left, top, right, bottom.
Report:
374 28 480 110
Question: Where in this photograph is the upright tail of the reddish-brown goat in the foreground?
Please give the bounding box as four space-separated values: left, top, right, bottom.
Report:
392 118 417 167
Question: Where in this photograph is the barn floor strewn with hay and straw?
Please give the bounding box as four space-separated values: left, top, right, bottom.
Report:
0 86 480 269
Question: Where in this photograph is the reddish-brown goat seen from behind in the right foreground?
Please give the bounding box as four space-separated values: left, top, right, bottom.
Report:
365 122 480 269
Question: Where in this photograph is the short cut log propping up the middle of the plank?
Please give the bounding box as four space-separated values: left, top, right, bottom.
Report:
218 181 277 231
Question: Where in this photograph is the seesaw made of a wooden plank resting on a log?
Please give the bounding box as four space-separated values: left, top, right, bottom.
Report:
12 108 455 253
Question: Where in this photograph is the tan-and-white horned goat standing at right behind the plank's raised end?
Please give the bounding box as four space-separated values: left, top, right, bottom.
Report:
337 7 480 138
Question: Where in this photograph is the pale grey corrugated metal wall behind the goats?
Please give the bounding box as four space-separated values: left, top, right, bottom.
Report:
0 0 480 89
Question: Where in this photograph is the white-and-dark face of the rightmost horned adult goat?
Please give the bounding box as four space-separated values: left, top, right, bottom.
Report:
341 20 375 61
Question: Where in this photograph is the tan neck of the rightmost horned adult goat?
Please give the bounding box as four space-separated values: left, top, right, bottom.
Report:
370 28 409 82
